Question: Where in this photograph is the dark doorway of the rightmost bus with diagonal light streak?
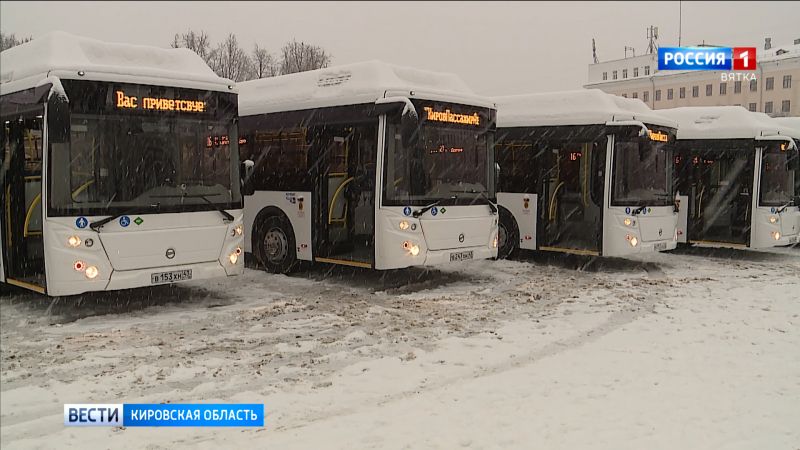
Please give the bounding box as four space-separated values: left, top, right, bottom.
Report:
689 148 755 245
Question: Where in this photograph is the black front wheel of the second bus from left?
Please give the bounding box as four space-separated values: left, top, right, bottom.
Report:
257 216 297 273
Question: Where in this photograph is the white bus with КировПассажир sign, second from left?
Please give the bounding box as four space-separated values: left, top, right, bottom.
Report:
239 61 497 273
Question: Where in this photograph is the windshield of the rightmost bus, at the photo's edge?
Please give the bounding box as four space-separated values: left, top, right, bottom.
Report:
759 143 800 206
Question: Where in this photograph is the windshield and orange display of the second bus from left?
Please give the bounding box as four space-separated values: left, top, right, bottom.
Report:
383 104 495 206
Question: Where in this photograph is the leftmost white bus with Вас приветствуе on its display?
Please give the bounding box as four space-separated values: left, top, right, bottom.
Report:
0 32 244 296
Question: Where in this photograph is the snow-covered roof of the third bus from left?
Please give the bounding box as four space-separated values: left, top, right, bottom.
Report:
494 89 676 128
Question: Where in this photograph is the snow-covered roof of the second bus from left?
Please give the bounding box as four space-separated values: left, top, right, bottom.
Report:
238 60 494 116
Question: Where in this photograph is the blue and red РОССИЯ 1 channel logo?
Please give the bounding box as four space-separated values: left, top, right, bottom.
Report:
658 47 756 70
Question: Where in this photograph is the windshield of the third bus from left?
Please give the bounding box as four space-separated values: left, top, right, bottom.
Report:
611 133 674 206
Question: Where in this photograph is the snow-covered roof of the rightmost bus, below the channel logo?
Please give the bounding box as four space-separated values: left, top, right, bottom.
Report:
659 106 789 139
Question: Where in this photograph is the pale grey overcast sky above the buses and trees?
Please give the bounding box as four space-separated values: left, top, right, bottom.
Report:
0 1 800 95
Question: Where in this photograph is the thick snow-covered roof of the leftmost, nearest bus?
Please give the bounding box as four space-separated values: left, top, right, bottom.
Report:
0 31 233 94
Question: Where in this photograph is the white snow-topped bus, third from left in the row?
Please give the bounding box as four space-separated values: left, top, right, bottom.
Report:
495 90 677 257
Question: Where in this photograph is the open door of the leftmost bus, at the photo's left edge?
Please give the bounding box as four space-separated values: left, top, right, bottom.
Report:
2 111 45 293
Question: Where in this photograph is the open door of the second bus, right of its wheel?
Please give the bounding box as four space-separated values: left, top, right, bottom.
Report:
316 124 378 268
